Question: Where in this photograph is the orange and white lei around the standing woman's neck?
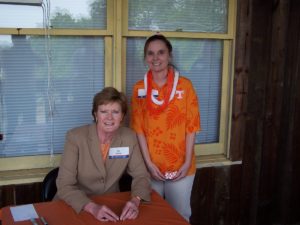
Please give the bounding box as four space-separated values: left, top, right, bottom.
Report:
144 69 179 113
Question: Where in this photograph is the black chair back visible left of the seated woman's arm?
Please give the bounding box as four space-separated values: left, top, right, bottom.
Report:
41 167 59 202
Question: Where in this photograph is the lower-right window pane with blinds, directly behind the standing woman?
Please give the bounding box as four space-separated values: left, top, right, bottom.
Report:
126 38 223 143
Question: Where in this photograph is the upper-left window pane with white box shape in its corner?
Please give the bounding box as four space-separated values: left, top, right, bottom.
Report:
0 0 106 29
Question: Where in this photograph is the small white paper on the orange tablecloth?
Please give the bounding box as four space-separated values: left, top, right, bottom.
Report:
10 204 39 222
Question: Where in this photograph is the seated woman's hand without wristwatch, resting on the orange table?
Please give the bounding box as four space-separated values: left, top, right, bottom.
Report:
84 202 120 222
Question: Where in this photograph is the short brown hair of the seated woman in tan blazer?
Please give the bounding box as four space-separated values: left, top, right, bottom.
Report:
92 87 127 121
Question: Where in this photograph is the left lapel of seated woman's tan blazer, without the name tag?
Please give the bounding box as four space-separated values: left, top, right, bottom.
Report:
88 124 106 177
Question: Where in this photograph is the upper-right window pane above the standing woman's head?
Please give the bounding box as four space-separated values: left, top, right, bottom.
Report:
128 0 228 33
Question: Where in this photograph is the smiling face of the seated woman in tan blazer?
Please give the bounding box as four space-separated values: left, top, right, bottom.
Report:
95 102 124 134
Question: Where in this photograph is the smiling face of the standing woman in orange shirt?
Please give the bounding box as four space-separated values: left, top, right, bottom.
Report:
145 40 171 73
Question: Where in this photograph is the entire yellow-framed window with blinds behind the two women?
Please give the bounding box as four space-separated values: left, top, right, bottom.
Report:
0 0 236 185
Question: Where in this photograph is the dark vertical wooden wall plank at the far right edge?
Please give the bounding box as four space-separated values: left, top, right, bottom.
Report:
273 0 300 224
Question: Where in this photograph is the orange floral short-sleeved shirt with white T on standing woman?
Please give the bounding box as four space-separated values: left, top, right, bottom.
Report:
131 76 200 175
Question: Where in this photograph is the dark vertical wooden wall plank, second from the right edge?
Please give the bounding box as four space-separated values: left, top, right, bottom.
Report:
257 1 289 224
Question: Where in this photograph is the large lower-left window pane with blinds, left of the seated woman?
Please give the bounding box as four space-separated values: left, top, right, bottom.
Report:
0 36 104 157
